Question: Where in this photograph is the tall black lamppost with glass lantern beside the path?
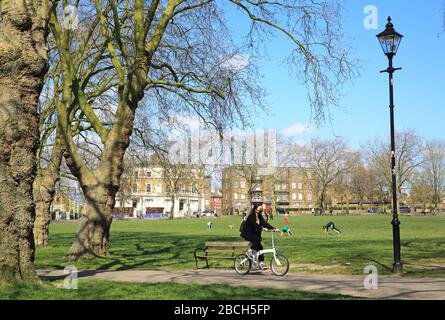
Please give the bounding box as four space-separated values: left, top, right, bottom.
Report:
377 17 403 274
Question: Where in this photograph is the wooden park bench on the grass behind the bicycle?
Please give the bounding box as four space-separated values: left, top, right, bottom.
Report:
193 241 249 269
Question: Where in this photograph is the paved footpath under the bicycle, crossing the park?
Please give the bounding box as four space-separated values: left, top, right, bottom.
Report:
38 269 445 300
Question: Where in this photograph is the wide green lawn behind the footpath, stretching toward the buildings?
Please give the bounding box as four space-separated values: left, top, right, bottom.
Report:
35 215 445 277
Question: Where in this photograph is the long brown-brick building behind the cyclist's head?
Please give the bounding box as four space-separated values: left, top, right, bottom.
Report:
222 165 317 214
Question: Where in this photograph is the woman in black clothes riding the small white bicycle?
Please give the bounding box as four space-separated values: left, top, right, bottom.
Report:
241 205 278 269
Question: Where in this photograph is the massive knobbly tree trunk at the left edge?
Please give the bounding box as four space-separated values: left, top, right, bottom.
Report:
0 0 49 281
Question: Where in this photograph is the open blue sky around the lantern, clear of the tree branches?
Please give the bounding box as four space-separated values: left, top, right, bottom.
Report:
225 0 445 148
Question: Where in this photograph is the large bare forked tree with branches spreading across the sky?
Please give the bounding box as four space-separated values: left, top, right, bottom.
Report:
46 0 355 258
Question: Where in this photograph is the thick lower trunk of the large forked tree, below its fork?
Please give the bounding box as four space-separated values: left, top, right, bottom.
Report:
68 184 117 260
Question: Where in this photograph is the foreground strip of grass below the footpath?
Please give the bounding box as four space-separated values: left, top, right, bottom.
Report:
0 280 357 300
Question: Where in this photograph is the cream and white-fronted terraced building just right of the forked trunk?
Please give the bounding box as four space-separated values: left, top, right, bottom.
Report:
115 163 211 218
